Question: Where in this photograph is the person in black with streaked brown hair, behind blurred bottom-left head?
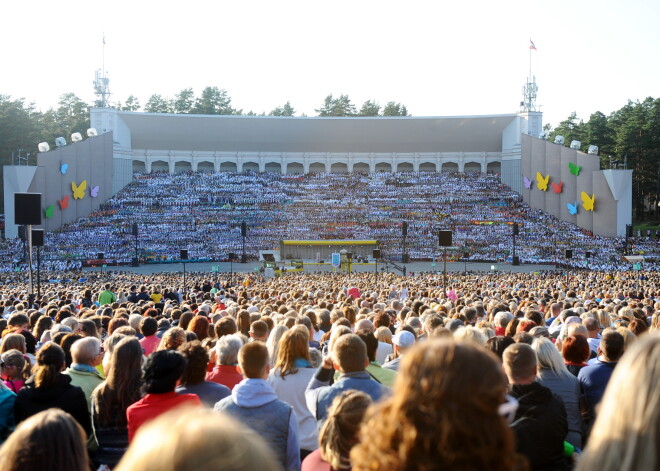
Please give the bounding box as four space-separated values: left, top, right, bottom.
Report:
14 342 92 435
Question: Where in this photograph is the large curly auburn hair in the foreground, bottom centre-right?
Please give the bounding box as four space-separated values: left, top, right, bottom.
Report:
351 339 516 471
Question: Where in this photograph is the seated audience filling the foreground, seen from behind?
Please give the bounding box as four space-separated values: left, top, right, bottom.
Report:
0 271 660 471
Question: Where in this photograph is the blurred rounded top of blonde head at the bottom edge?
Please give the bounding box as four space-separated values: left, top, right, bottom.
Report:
115 407 280 471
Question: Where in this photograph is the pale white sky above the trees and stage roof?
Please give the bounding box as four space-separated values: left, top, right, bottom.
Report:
0 0 660 126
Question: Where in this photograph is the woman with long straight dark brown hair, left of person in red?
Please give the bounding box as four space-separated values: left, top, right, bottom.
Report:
92 337 142 468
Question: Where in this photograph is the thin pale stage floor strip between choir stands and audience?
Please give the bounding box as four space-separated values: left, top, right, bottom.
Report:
83 262 557 276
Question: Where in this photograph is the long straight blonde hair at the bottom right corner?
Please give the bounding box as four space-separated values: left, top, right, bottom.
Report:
577 333 660 471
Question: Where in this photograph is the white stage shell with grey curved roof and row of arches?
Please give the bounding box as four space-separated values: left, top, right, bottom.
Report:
91 108 542 192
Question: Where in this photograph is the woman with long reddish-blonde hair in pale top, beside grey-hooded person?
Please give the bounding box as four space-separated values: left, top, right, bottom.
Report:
268 325 318 460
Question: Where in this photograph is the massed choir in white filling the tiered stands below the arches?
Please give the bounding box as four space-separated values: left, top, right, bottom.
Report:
0 172 660 271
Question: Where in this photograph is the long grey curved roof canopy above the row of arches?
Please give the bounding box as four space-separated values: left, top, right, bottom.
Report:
117 112 516 153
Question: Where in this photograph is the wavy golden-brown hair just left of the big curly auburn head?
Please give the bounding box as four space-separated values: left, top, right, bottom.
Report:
319 390 371 470
